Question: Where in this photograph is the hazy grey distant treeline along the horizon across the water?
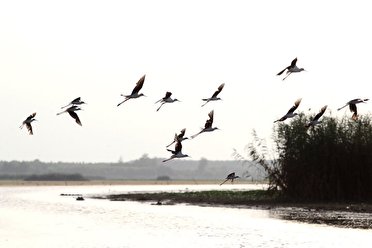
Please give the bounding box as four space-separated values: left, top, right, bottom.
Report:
0 157 266 180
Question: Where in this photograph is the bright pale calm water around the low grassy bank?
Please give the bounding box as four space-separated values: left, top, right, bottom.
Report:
0 185 372 248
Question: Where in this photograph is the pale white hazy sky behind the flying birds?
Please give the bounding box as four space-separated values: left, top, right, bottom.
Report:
0 0 372 162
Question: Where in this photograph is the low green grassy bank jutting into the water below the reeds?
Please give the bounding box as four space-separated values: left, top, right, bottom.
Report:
106 190 372 213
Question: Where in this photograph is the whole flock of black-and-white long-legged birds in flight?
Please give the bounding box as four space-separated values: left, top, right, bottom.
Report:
20 58 369 185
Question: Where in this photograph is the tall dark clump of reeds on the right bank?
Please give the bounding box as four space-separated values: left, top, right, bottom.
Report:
248 114 372 201
